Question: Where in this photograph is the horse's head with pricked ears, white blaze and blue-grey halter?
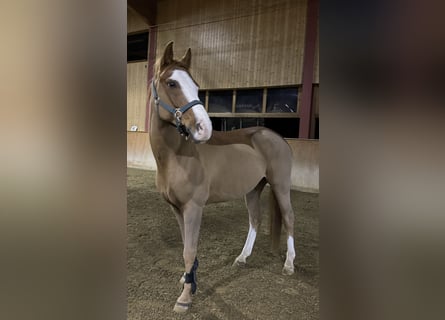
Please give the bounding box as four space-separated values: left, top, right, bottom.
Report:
152 42 212 143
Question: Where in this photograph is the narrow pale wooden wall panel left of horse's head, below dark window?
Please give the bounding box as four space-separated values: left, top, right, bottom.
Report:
127 61 148 131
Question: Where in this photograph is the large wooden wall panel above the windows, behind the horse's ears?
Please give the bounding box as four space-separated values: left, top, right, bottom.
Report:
157 0 307 89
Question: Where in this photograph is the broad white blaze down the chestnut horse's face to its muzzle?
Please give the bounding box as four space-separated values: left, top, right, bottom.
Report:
170 70 212 142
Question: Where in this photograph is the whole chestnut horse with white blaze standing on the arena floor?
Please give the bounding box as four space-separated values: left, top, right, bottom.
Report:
149 42 295 312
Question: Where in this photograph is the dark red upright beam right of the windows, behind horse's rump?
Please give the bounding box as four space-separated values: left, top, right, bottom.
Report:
298 0 319 139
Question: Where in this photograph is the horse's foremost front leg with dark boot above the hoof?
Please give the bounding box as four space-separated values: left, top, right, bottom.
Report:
173 202 202 312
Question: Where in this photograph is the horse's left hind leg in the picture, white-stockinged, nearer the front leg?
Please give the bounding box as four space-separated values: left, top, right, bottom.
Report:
233 179 267 266
